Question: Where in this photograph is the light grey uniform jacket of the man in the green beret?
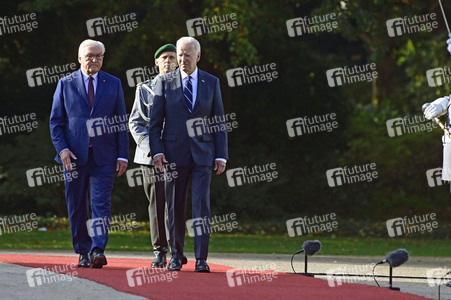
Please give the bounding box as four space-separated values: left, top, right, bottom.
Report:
128 76 158 165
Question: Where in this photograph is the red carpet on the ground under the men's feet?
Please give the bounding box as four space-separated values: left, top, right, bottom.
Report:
0 255 426 300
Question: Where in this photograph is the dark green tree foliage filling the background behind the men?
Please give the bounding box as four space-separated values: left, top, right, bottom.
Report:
0 0 451 236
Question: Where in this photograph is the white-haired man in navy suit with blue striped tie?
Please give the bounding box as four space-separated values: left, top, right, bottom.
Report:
149 37 228 272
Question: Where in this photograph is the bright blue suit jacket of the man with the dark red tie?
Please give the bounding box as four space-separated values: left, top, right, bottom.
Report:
50 69 128 165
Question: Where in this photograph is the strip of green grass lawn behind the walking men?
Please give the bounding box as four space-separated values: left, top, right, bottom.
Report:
0 230 451 256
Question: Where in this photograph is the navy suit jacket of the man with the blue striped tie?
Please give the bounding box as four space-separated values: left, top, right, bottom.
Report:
149 69 228 166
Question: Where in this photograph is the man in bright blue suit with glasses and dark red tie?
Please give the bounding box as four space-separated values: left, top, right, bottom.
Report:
50 40 128 268
